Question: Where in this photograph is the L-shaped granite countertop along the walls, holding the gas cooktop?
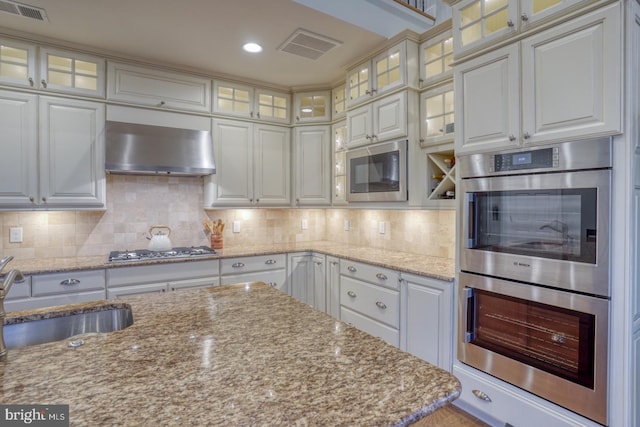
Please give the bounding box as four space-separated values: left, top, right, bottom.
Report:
8 241 455 282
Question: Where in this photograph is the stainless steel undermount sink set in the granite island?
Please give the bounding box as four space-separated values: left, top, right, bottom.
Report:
4 306 133 349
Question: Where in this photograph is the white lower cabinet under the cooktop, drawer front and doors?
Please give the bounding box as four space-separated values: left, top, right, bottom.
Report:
106 259 220 299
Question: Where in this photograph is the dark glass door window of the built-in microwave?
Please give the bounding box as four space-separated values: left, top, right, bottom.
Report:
350 150 400 193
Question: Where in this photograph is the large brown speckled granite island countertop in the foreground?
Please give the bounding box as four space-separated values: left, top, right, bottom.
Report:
0 283 460 426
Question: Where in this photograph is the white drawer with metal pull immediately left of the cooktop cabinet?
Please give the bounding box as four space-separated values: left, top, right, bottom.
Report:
31 270 105 297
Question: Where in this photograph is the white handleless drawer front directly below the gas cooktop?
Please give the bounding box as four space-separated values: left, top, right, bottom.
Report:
107 259 219 288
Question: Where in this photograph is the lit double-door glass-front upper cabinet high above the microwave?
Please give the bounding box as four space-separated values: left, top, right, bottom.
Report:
346 40 418 107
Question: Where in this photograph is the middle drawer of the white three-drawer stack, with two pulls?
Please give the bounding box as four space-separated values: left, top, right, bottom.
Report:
340 277 400 328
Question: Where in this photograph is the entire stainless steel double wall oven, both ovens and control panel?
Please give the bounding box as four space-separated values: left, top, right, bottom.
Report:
458 138 612 425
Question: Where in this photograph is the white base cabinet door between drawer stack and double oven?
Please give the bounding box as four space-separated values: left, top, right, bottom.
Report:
400 273 455 371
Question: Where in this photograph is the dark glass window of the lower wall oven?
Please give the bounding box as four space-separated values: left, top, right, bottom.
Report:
467 289 596 388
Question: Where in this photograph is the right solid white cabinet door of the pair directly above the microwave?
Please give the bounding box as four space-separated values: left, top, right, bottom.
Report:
372 91 407 142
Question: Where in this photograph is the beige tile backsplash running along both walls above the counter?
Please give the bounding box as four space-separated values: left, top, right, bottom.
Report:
0 175 455 259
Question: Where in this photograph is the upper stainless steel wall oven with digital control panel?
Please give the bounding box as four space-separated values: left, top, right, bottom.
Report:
458 138 612 297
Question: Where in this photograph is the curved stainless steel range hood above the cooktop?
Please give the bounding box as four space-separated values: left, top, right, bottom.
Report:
105 121 216 176
